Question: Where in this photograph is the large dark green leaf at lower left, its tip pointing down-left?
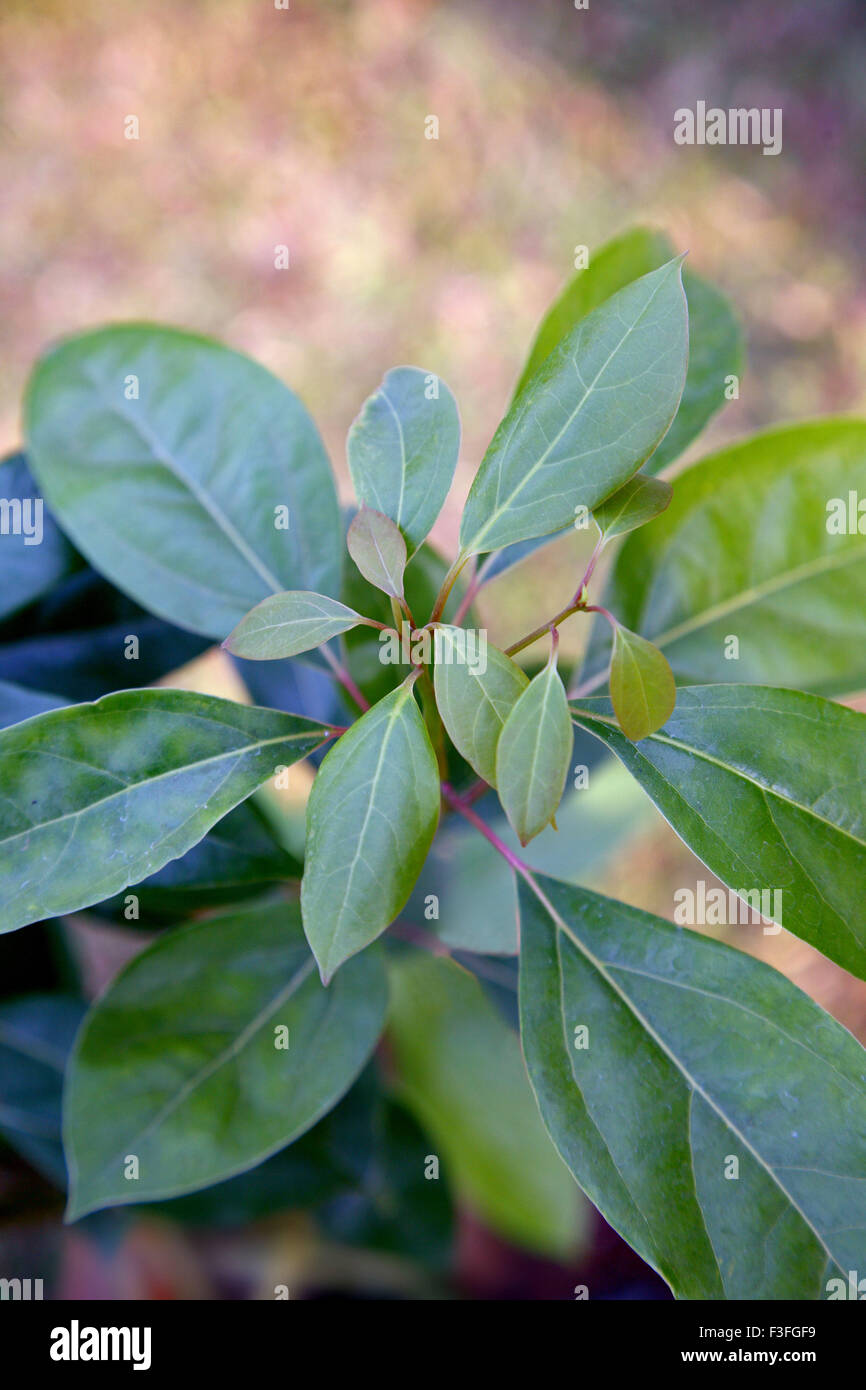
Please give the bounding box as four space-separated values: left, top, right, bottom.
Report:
64 902 386 1220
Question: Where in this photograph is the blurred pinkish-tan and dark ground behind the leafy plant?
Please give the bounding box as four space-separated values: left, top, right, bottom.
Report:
0 0 866 1298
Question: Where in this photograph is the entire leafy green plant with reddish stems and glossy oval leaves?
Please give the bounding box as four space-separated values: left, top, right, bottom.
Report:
0 229 866 1298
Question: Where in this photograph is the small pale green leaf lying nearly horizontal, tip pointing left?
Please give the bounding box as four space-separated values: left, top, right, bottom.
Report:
222 589 367 662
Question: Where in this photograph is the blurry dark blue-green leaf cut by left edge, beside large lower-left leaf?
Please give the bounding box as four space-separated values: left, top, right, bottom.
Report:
0 994 85 1187
